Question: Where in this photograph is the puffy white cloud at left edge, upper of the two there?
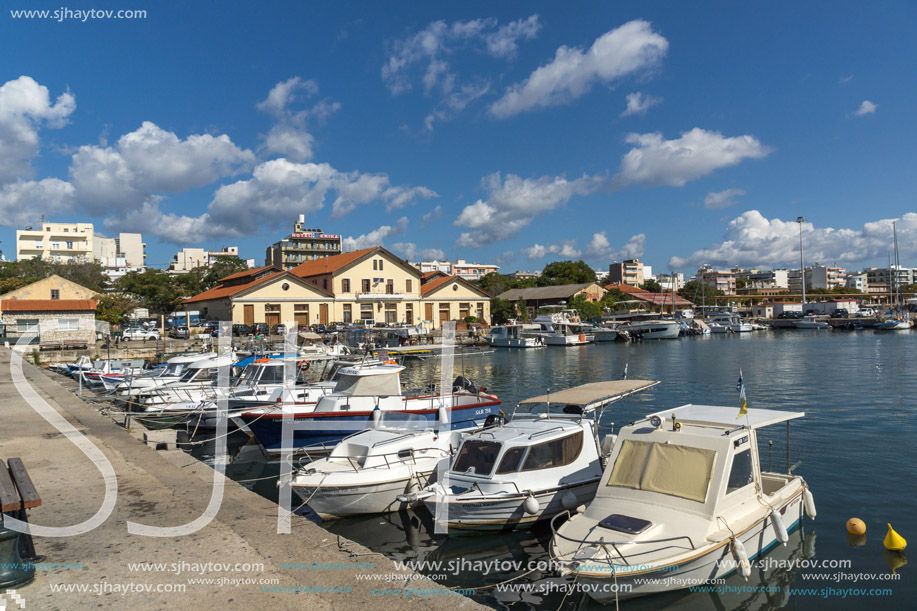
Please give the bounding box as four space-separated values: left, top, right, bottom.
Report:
0 76 76 185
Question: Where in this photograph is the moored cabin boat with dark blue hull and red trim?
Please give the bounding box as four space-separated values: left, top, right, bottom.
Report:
238 363 501 455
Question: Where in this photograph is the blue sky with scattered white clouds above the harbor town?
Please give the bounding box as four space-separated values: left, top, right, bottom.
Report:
0 0 917 273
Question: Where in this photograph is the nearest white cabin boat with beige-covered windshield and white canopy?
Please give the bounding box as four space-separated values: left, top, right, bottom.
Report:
550 405 815 602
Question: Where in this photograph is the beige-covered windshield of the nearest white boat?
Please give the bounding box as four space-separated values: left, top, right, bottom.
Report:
606 439 716 503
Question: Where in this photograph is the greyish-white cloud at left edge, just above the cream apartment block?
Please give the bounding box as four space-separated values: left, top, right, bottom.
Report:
0 178 74 227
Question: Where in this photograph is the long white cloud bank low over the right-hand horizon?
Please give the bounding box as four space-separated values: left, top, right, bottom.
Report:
669 210 917 269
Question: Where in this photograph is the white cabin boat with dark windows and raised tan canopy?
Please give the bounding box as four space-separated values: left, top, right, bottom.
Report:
403 380 658 531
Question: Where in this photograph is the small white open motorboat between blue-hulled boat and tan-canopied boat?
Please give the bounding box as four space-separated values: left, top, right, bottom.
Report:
290 412 476 520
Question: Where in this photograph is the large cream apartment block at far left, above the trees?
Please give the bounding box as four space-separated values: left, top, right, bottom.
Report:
16 222 146 268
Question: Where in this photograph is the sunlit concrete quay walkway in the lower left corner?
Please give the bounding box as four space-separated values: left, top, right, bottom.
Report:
0 350 484 610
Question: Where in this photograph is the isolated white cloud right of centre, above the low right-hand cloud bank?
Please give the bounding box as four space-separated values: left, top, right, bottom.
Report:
614 127 772 187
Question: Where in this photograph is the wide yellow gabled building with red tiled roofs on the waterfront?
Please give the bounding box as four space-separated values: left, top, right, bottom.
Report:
184 246 491 327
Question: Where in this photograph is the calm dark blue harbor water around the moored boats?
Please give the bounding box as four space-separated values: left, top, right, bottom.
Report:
199 330 917 610
